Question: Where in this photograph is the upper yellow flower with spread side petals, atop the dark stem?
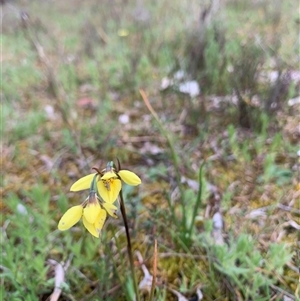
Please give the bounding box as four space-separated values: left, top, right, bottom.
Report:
70 162 141 204
